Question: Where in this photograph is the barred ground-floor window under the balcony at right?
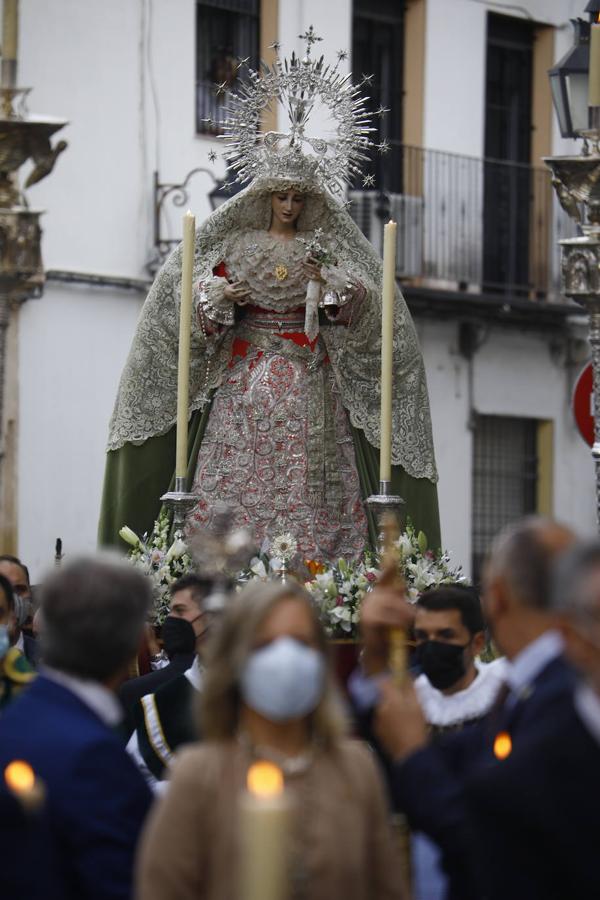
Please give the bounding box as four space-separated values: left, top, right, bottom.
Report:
472 416 538 584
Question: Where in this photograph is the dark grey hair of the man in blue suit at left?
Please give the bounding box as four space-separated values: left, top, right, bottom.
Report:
40 554 152 681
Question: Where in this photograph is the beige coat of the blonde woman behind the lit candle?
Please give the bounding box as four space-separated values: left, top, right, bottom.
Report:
136 740 402 900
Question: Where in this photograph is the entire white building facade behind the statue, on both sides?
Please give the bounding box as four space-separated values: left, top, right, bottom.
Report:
9 0 593 579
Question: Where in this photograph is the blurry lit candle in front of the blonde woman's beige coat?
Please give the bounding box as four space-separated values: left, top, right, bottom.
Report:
238 762 290 900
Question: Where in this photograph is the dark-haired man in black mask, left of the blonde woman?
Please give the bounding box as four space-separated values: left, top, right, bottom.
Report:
119 574 213 734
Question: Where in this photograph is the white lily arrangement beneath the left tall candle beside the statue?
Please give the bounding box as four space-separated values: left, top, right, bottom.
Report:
119 510 193 624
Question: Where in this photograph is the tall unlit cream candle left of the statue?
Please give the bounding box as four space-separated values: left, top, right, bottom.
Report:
175 210 196 478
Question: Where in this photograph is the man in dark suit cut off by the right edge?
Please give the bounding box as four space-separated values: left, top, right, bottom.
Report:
468 540 600 900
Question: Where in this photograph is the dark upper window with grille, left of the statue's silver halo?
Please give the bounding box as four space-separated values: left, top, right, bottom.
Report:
196 0 260 134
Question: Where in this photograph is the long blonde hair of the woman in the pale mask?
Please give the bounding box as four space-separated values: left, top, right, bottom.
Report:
199 581 346 747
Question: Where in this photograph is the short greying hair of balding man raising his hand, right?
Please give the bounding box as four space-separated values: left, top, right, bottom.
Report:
488 516 574 611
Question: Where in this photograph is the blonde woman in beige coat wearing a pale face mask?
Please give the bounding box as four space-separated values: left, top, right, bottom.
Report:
137 583 402 900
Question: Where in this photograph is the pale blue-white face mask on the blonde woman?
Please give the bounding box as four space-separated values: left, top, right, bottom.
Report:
240 637 325 722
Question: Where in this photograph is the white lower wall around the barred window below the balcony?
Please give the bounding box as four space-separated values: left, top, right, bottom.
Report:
418 320 595 573
